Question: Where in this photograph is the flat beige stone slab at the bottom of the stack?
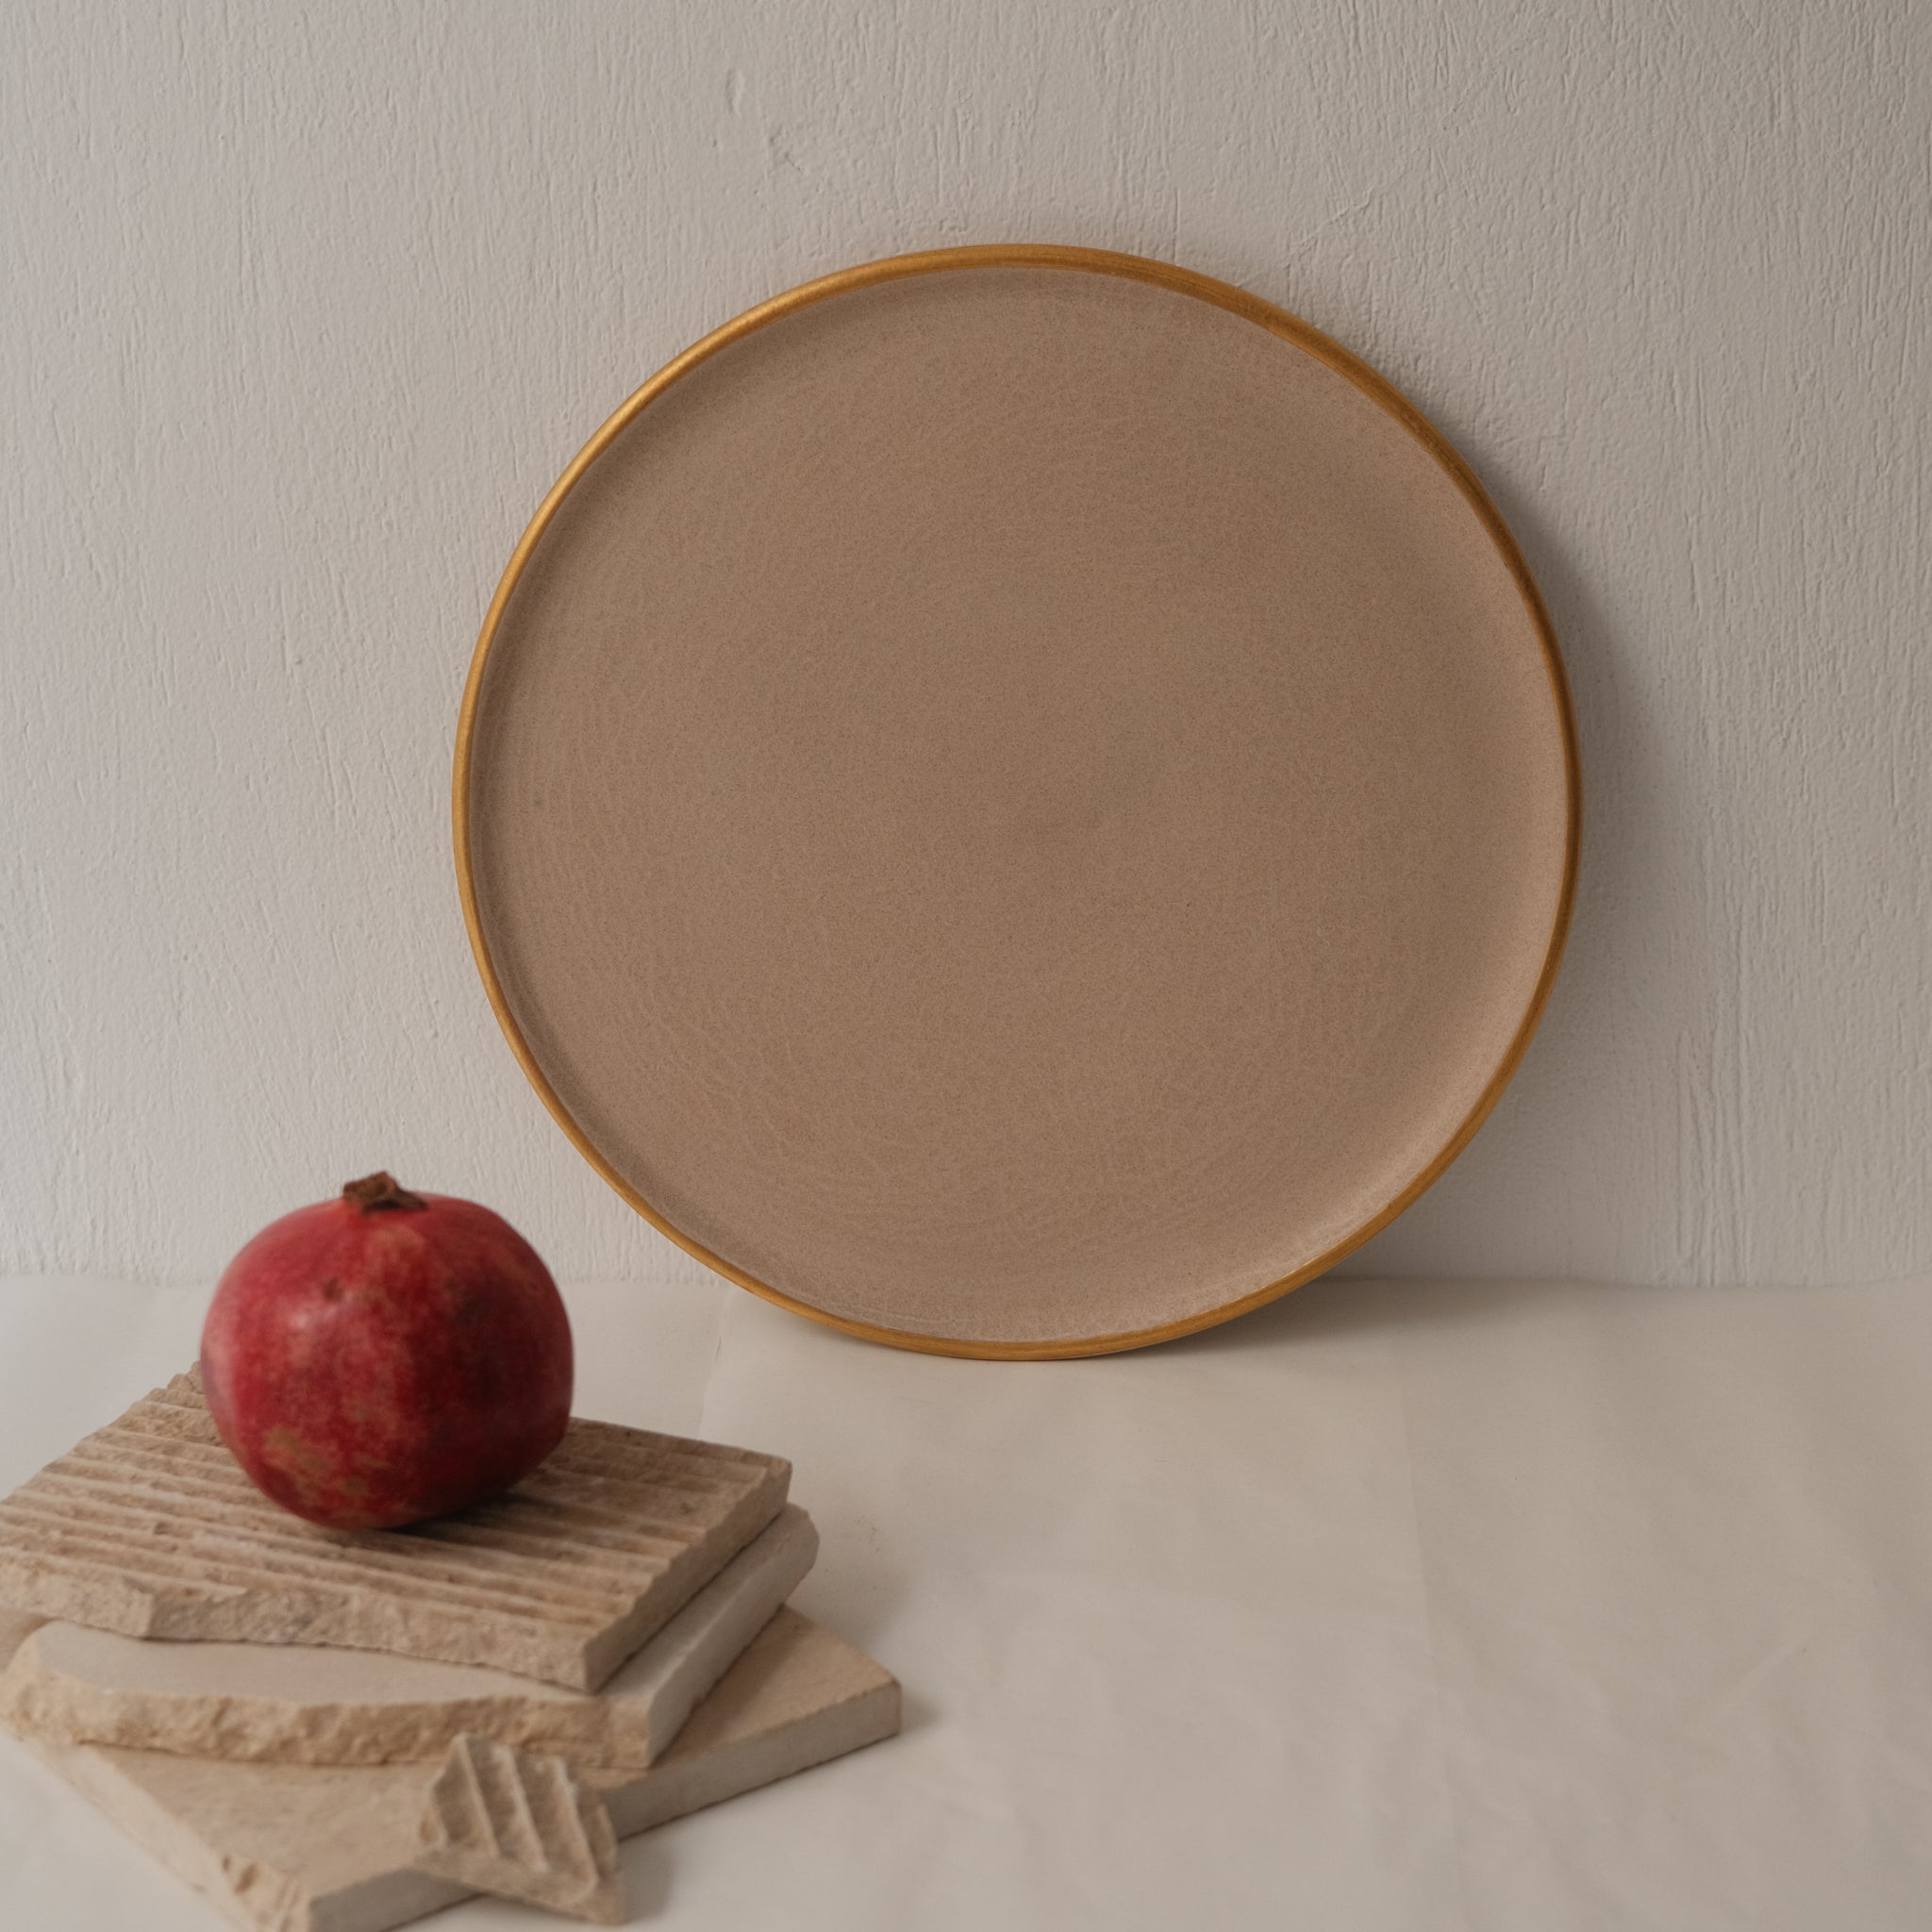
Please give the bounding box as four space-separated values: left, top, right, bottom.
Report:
15 1609 898 1932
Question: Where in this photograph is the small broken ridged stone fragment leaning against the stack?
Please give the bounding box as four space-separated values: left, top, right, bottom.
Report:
415 1737 625 1926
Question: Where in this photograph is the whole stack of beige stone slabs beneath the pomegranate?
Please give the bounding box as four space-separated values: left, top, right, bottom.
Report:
0 1375 898 1932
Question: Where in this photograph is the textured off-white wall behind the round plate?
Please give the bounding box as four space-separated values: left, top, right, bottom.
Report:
0 0 1932 1281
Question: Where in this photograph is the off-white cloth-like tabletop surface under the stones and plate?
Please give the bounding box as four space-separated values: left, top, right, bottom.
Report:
0 1281 1932 1932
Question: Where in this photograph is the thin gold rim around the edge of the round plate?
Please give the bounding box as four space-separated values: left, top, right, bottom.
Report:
452 243 1582 1362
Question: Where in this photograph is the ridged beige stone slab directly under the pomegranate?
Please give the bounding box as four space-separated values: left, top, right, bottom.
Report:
0 1375 792 1690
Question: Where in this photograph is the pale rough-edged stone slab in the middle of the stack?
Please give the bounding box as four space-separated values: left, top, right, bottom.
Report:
0 1503 819 1770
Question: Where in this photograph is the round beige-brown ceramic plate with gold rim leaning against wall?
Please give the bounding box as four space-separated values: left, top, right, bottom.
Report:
456 247 1576 1357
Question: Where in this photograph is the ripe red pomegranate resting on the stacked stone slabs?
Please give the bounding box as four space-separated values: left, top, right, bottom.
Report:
201 1174 572 1530
